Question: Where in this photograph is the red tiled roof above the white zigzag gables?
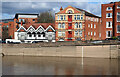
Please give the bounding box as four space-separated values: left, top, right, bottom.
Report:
23 23 55 30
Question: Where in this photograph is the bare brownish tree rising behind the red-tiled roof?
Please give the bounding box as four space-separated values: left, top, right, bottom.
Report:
38 11 55 23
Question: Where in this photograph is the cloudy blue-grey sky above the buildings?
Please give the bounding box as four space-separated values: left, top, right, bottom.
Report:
0 0 118 19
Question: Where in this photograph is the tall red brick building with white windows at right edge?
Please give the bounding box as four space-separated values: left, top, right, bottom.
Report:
101 2 120 40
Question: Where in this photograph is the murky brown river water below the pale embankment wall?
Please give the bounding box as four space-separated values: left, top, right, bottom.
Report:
2 56 118 75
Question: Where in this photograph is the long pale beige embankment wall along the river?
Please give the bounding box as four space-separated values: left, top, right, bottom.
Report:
2 45 120 58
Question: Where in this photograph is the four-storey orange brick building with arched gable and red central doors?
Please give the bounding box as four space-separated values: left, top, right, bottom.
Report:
55 6 101 41
